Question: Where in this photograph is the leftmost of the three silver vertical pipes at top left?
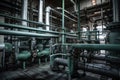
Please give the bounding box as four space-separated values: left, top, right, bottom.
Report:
22 0 28 26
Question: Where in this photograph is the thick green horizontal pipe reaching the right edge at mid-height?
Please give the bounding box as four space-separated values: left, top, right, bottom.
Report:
64 44 120 51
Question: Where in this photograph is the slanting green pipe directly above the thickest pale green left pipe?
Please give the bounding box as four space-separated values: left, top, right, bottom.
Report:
0 22 77 37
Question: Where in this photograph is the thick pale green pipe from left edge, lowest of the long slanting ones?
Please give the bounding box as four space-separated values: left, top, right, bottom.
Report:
0 30 58 38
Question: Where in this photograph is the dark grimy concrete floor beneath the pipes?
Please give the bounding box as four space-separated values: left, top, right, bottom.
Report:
0 64 100 80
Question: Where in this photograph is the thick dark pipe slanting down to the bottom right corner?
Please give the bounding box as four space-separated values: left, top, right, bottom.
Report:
78 63 120 79
